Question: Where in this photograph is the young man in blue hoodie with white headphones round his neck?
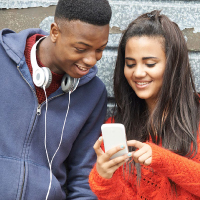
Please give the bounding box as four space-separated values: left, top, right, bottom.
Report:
0 0 111 200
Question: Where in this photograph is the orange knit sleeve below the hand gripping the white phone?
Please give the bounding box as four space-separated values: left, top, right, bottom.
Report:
89 165 137 200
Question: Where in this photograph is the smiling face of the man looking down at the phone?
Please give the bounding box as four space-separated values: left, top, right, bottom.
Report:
51 20 109 78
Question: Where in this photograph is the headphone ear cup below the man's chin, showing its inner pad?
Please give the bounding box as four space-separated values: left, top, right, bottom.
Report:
61 74 79 93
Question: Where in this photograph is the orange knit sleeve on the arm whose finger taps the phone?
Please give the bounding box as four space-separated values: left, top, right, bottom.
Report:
148 141 200 197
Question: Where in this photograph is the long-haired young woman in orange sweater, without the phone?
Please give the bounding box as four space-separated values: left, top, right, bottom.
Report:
89 11 200 200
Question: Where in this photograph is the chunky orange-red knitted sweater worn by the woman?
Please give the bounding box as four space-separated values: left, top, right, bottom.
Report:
89 119 200 200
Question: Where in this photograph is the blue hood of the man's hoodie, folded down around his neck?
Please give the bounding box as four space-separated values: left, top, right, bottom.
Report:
0 28 97 86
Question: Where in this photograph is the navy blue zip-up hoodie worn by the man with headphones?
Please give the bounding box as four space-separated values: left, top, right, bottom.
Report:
0 29 106 200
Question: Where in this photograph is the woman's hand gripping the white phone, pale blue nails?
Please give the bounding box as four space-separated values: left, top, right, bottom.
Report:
93 137 132 179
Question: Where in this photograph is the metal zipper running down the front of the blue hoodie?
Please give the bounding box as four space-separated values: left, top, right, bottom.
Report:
17 65 64 200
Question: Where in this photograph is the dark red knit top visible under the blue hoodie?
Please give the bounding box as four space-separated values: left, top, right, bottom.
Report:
24 34 63 104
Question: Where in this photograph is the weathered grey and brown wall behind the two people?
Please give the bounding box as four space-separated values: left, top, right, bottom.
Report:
0 0 200 116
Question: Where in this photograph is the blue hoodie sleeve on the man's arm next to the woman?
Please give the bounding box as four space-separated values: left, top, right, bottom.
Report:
67 83 107 200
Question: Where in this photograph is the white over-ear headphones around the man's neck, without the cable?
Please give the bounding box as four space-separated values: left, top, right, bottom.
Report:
30 36 80 93
